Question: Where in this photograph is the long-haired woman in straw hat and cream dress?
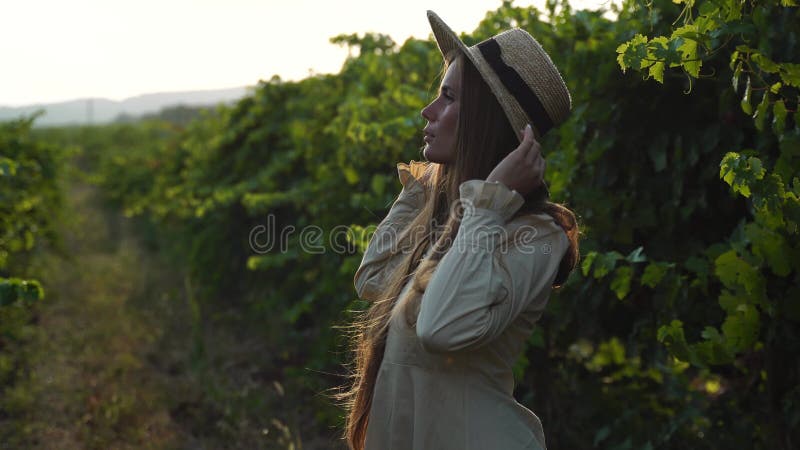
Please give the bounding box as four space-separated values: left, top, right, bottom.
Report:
342 11 579 450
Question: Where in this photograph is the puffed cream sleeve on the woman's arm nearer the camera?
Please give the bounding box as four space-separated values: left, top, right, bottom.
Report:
416 180 569 352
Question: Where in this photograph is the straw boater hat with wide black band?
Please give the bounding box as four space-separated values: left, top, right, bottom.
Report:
428 11 572 140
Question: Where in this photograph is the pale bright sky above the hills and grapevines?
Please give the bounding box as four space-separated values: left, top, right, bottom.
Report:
0 0 620 106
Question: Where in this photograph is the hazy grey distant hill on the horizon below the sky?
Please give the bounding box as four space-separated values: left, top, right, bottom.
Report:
0 86 249 127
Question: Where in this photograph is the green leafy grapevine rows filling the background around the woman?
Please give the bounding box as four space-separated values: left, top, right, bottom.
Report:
0 0 800 450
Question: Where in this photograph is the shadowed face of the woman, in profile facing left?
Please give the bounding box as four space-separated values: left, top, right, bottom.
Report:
422 58 461 164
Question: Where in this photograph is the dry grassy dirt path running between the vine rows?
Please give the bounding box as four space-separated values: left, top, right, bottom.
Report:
20 184 186 449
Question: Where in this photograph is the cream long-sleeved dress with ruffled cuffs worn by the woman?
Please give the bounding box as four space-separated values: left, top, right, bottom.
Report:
354 161 569 450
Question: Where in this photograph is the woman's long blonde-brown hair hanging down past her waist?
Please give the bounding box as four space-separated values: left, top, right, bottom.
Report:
333 53 579 450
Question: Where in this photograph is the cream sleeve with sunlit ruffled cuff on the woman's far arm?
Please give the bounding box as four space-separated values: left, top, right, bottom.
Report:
353 161 427 301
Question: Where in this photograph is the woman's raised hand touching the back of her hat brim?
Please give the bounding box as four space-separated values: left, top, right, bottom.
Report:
486 125 546 197
